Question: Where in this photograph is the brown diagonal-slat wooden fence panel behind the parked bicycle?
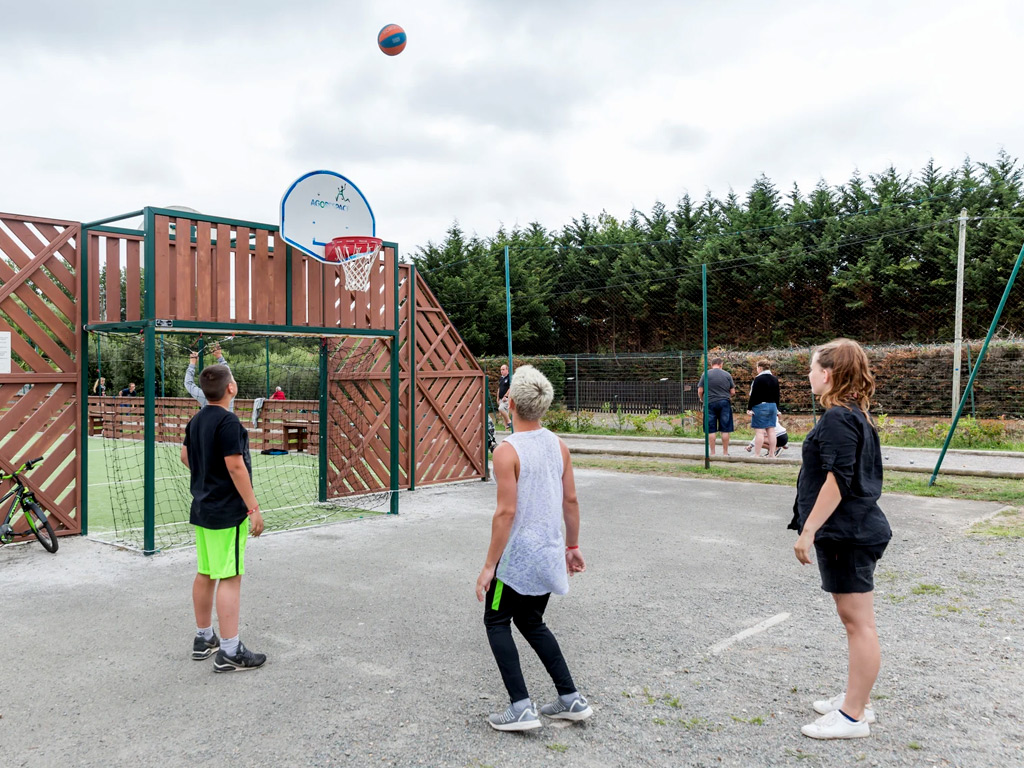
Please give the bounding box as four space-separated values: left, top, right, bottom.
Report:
0 213 80 535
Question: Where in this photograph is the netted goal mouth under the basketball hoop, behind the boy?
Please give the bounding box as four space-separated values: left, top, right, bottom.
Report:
88 333 392 550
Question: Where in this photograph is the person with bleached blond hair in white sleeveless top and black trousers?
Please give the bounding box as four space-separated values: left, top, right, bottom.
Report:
476 366 592 731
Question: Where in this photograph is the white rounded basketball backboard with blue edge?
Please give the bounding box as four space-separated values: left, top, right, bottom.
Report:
281 171 377 261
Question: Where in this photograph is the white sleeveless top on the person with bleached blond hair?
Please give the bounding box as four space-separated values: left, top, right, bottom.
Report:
497 428 569 595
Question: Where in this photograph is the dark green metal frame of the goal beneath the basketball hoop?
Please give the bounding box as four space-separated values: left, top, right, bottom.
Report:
79 207 401 554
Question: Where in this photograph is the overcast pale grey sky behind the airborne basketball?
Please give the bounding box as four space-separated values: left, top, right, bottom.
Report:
0 0 1024 252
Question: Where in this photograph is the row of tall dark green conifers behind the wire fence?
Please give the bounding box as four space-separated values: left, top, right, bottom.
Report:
414 152 1024 355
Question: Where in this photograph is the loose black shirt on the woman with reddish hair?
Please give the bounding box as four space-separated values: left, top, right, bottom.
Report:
790 403 892 546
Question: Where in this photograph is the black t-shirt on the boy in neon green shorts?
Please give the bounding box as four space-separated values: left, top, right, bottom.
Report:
184 406 253 529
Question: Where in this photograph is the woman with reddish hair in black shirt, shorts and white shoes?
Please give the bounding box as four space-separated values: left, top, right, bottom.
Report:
790 339 892 738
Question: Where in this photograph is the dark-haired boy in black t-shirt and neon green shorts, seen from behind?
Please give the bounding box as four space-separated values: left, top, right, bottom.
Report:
181 365 266 672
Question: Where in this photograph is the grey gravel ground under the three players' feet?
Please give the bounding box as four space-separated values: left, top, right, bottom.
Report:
0 470 1024 768
